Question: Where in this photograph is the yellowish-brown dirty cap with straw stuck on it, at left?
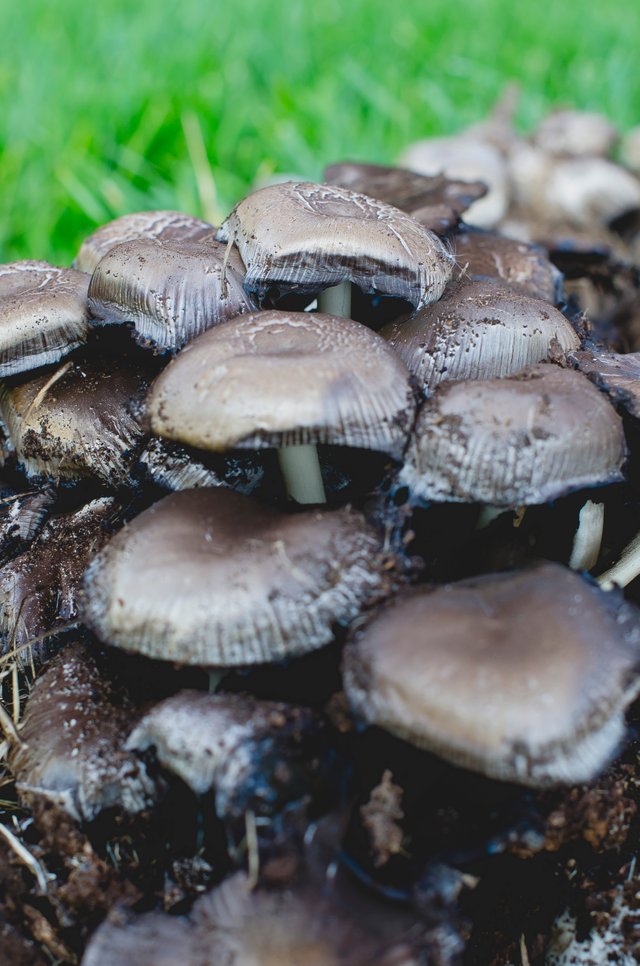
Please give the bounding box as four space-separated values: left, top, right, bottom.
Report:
0 356 154 486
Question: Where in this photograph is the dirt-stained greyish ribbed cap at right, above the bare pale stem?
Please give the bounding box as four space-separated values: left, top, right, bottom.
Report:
399 365 626 507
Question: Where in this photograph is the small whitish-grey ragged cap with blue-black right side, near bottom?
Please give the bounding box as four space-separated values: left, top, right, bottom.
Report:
126 691 335 819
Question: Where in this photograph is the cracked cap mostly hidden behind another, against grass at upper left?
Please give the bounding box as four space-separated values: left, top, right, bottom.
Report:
74 211 215 272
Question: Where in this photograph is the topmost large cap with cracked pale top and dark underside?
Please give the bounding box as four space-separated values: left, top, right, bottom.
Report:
216 181 453 309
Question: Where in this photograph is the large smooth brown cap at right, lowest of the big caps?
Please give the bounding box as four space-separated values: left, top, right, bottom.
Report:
344 564 640 786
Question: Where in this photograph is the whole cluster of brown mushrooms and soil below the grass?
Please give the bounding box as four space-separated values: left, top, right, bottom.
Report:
0 105 640 966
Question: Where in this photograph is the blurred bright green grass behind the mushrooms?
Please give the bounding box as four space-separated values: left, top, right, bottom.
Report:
0 0 640 264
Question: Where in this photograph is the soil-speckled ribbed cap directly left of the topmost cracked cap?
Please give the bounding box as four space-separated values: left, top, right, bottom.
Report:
89 238 256 351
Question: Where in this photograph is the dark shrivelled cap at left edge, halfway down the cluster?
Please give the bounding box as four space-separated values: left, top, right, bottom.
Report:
0 497 117 664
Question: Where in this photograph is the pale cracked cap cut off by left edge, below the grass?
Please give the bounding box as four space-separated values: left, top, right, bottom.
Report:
0 261 89 377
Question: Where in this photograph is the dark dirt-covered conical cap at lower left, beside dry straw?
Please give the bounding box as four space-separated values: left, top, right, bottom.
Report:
9 643 155 822
